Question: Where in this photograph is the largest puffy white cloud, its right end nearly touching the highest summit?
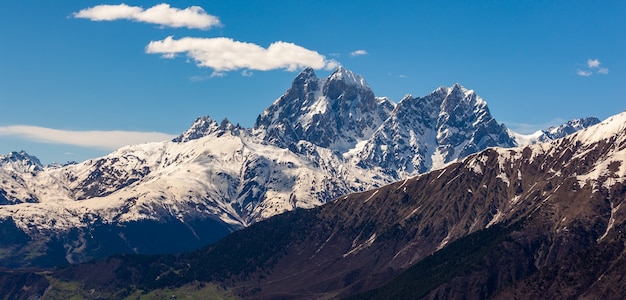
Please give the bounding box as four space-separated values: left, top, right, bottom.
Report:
146 36 339 73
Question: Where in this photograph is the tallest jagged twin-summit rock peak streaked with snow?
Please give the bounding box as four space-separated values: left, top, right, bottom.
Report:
255 68 393 152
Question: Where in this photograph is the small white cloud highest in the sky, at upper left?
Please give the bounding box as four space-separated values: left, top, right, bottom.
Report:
73 3 221 29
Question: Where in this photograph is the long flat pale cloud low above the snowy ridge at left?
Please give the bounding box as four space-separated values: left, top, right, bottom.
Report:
0 125 174 150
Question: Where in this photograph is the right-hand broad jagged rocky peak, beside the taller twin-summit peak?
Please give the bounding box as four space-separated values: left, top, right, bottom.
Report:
357 84 515 180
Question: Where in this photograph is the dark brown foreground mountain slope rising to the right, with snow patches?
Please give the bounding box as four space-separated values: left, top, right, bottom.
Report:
0 104 626 299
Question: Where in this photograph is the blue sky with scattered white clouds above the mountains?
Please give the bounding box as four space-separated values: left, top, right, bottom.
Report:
0 0 626 163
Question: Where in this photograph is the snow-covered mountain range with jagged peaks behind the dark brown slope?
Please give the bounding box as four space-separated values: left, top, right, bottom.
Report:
0 67 599 267
